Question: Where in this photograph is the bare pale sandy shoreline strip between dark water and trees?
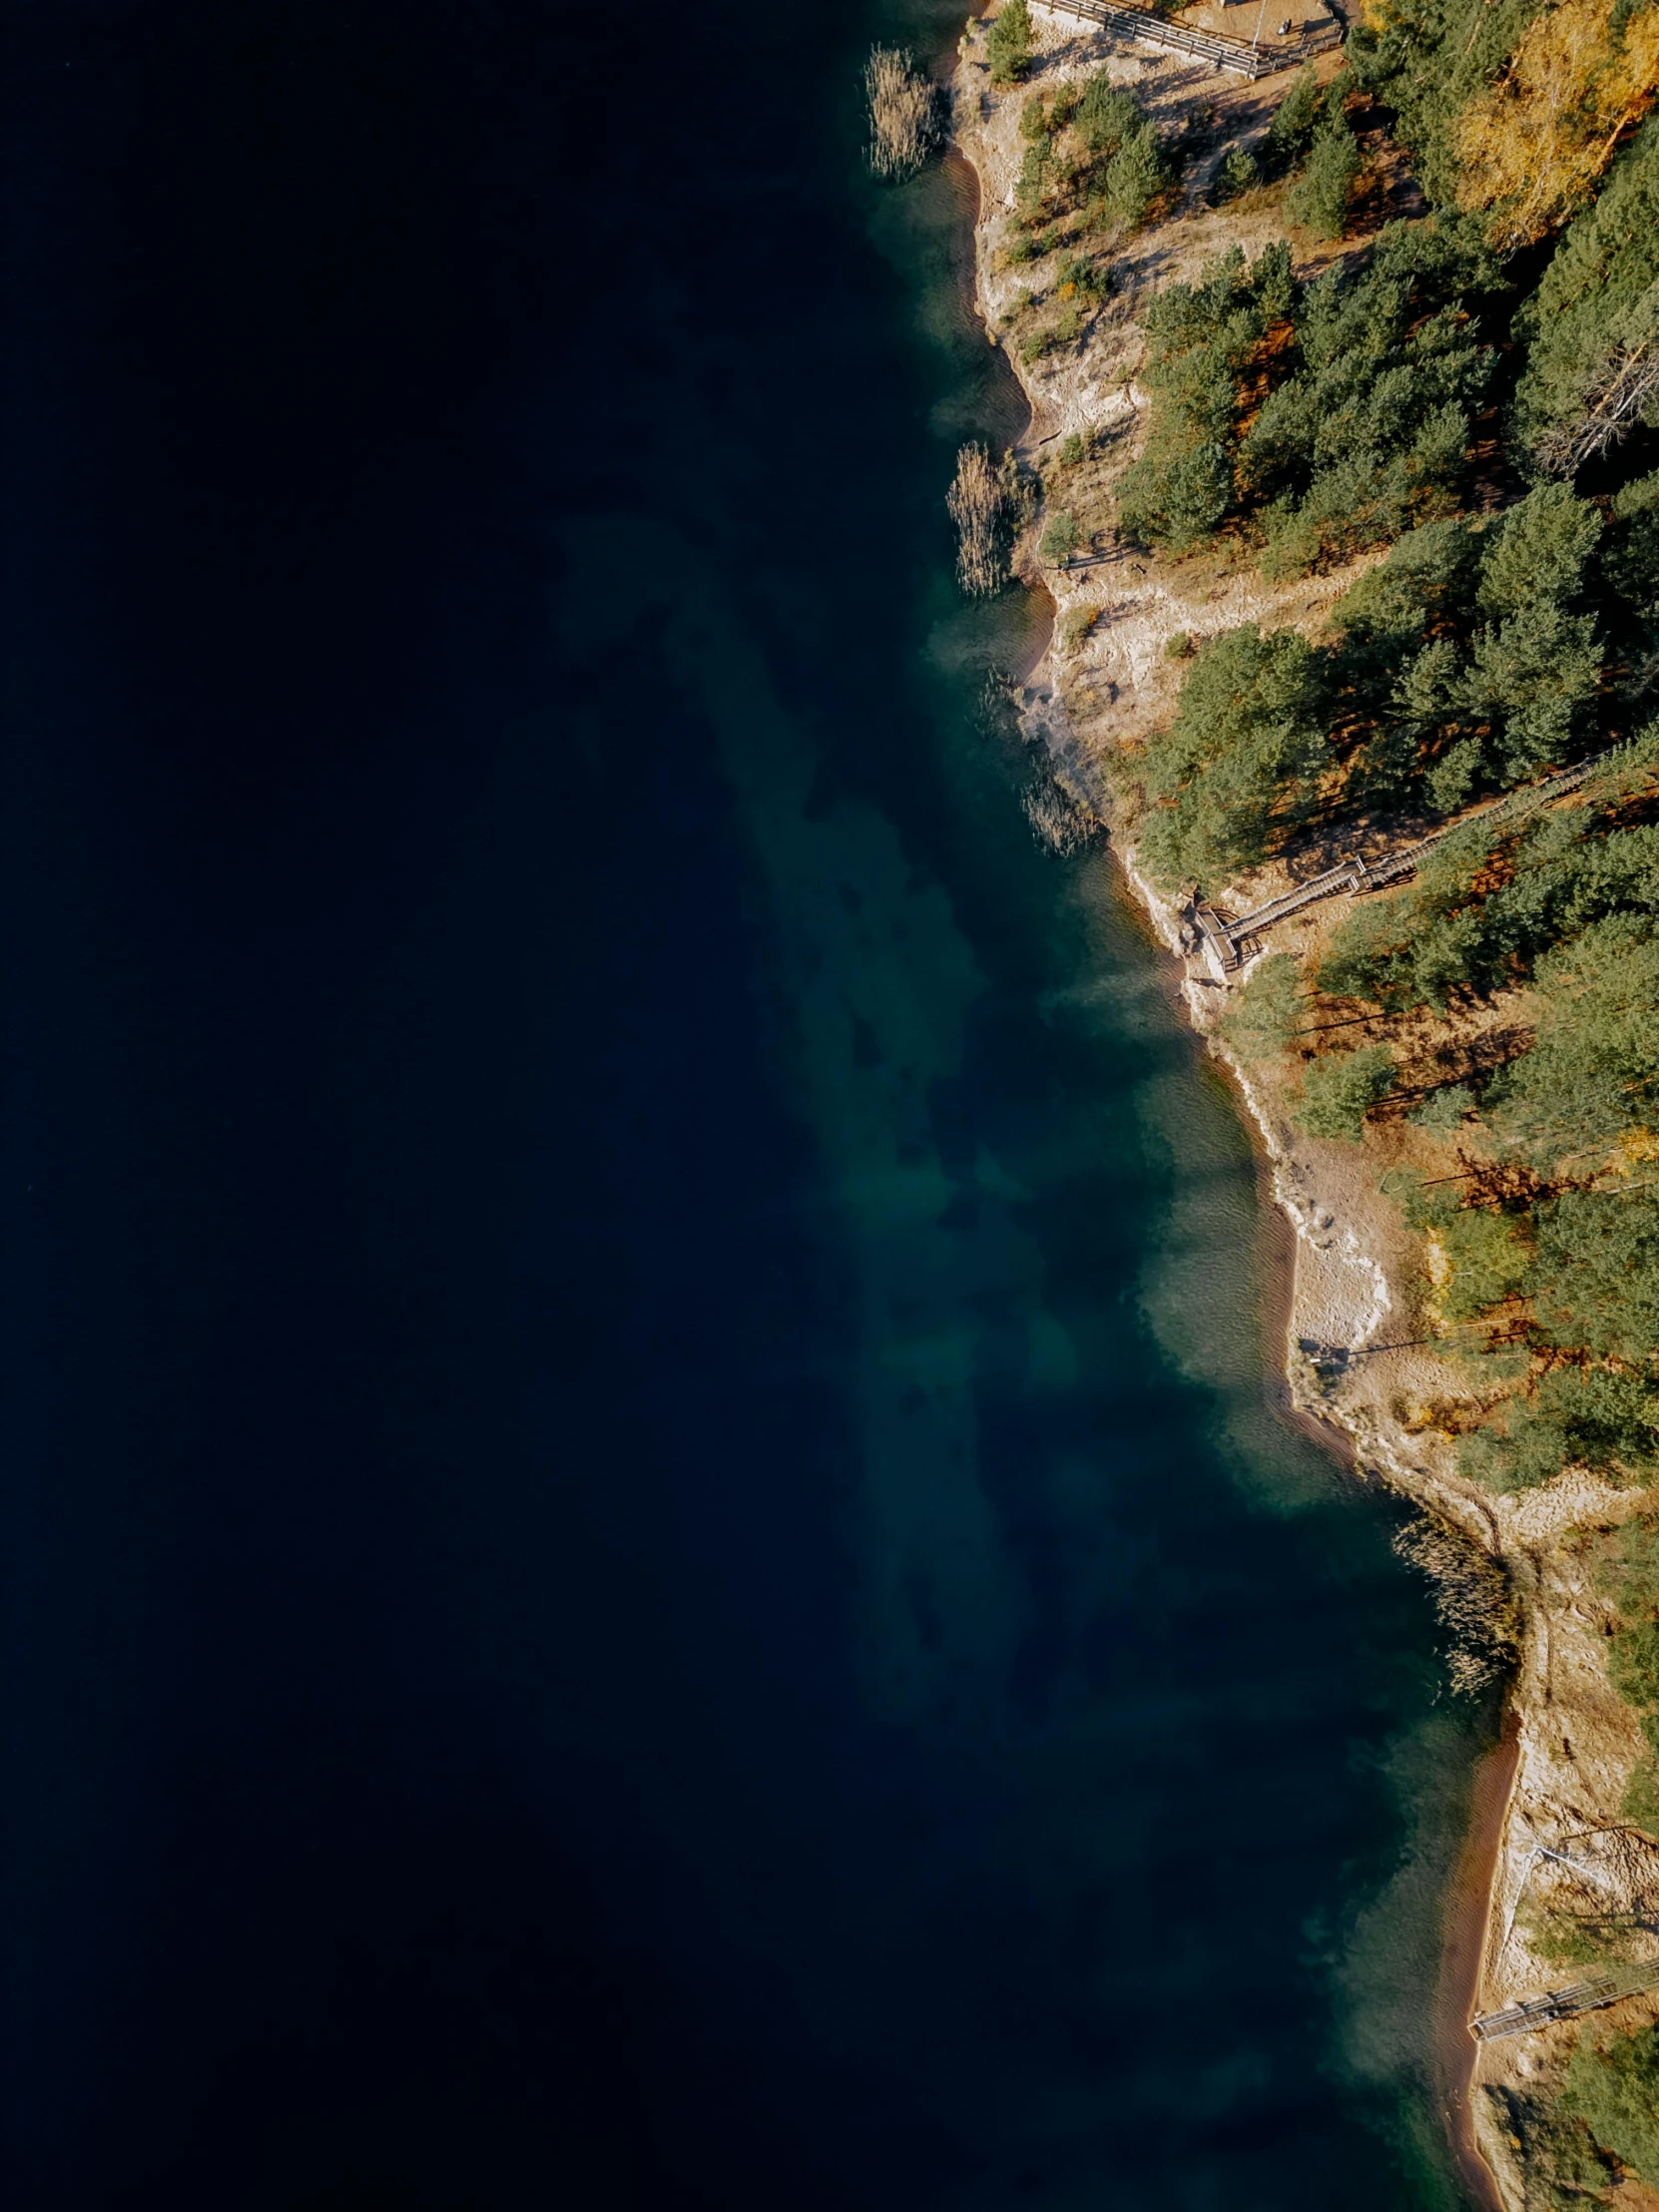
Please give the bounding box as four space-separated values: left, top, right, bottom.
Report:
949 21 1659 2212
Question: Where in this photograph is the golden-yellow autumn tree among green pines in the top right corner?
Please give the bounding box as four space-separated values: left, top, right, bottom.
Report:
1455 0 1659 246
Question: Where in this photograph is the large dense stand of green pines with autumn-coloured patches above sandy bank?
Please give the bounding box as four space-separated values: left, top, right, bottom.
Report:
1119 0 1659 1488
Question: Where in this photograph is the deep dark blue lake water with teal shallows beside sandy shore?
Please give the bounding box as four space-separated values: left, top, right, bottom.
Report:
0 0 1475 2212
